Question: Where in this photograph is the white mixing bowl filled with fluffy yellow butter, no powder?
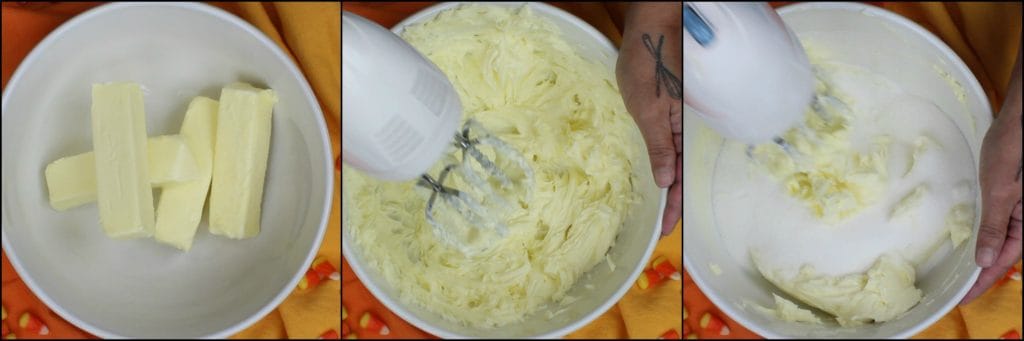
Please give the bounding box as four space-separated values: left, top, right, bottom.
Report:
341 2 667 338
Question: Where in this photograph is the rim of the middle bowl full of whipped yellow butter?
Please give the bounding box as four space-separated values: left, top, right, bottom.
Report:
341 2 669 339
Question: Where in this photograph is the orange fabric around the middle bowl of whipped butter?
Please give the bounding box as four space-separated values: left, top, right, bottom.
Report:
341 2 683 339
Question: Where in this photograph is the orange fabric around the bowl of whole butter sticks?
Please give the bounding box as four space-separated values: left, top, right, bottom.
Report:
2 2 341 339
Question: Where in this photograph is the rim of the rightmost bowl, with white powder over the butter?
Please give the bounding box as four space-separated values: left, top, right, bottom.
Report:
683 2 991 339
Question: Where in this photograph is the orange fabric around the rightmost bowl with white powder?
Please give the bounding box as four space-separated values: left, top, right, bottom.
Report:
683 2 1021 339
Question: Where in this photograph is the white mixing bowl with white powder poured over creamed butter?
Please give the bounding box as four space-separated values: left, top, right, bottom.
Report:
683 3 991 338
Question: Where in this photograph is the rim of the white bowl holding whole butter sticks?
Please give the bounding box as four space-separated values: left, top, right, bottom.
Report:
0 2 334 339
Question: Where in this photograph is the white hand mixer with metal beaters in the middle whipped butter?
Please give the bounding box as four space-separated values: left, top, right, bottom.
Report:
341 11 532 253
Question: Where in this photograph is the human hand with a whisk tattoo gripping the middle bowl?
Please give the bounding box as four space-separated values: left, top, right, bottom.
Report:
615 3 683 237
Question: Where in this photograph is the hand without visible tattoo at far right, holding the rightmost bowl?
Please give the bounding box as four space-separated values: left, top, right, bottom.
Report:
961 47 1022 303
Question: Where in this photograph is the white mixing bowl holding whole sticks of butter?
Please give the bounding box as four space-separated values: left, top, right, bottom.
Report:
2 3 334 338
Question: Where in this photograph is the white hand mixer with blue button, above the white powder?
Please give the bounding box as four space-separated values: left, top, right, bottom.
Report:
683 2 838 146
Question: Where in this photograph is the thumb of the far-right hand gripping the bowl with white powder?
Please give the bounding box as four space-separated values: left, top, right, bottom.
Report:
975 197 1016 267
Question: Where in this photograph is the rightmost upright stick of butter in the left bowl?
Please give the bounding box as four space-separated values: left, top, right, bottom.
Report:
210 83 278 239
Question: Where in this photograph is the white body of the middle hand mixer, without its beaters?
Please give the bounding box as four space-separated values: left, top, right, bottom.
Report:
341 11 462 180
